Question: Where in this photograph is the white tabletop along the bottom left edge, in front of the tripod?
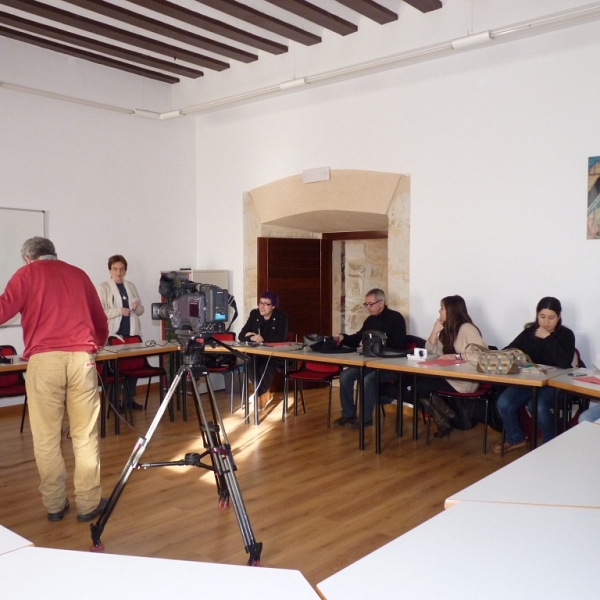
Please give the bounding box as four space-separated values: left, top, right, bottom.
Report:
0 541 319 600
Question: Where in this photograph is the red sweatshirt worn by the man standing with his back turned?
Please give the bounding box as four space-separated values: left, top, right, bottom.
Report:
0 259 108 358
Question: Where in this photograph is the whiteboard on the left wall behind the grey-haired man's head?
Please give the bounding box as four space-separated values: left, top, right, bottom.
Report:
0 206 45 325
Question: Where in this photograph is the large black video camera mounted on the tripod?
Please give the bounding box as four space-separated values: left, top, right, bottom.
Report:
152 271 230 334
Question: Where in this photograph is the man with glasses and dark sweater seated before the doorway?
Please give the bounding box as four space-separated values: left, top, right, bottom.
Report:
333 288 406 429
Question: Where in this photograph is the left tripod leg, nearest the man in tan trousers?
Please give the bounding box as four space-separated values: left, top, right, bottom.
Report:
90 367 189 552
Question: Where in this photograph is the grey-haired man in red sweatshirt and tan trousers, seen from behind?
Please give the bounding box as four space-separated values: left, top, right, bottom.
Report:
0 237 108 521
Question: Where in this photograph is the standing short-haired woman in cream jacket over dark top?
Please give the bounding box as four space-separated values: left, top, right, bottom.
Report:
96 254 144 410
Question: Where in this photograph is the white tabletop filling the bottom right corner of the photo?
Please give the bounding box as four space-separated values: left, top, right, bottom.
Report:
317 502 600 600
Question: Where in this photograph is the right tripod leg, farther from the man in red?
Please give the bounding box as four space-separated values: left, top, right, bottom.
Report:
192 377 262 566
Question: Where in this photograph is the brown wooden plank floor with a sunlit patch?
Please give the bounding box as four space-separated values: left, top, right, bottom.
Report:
0 390 523 585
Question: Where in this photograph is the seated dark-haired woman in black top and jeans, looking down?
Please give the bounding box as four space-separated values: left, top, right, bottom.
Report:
494 296 575 453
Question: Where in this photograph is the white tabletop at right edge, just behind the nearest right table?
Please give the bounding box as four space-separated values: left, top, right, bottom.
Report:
445 423 600 508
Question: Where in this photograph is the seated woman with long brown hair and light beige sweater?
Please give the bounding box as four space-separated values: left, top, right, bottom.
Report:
417 296 487 437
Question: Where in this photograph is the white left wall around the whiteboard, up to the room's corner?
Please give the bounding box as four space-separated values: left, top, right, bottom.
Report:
0 71 196 351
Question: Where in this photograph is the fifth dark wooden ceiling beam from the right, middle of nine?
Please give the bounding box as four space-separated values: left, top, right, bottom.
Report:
126 0 287 54
